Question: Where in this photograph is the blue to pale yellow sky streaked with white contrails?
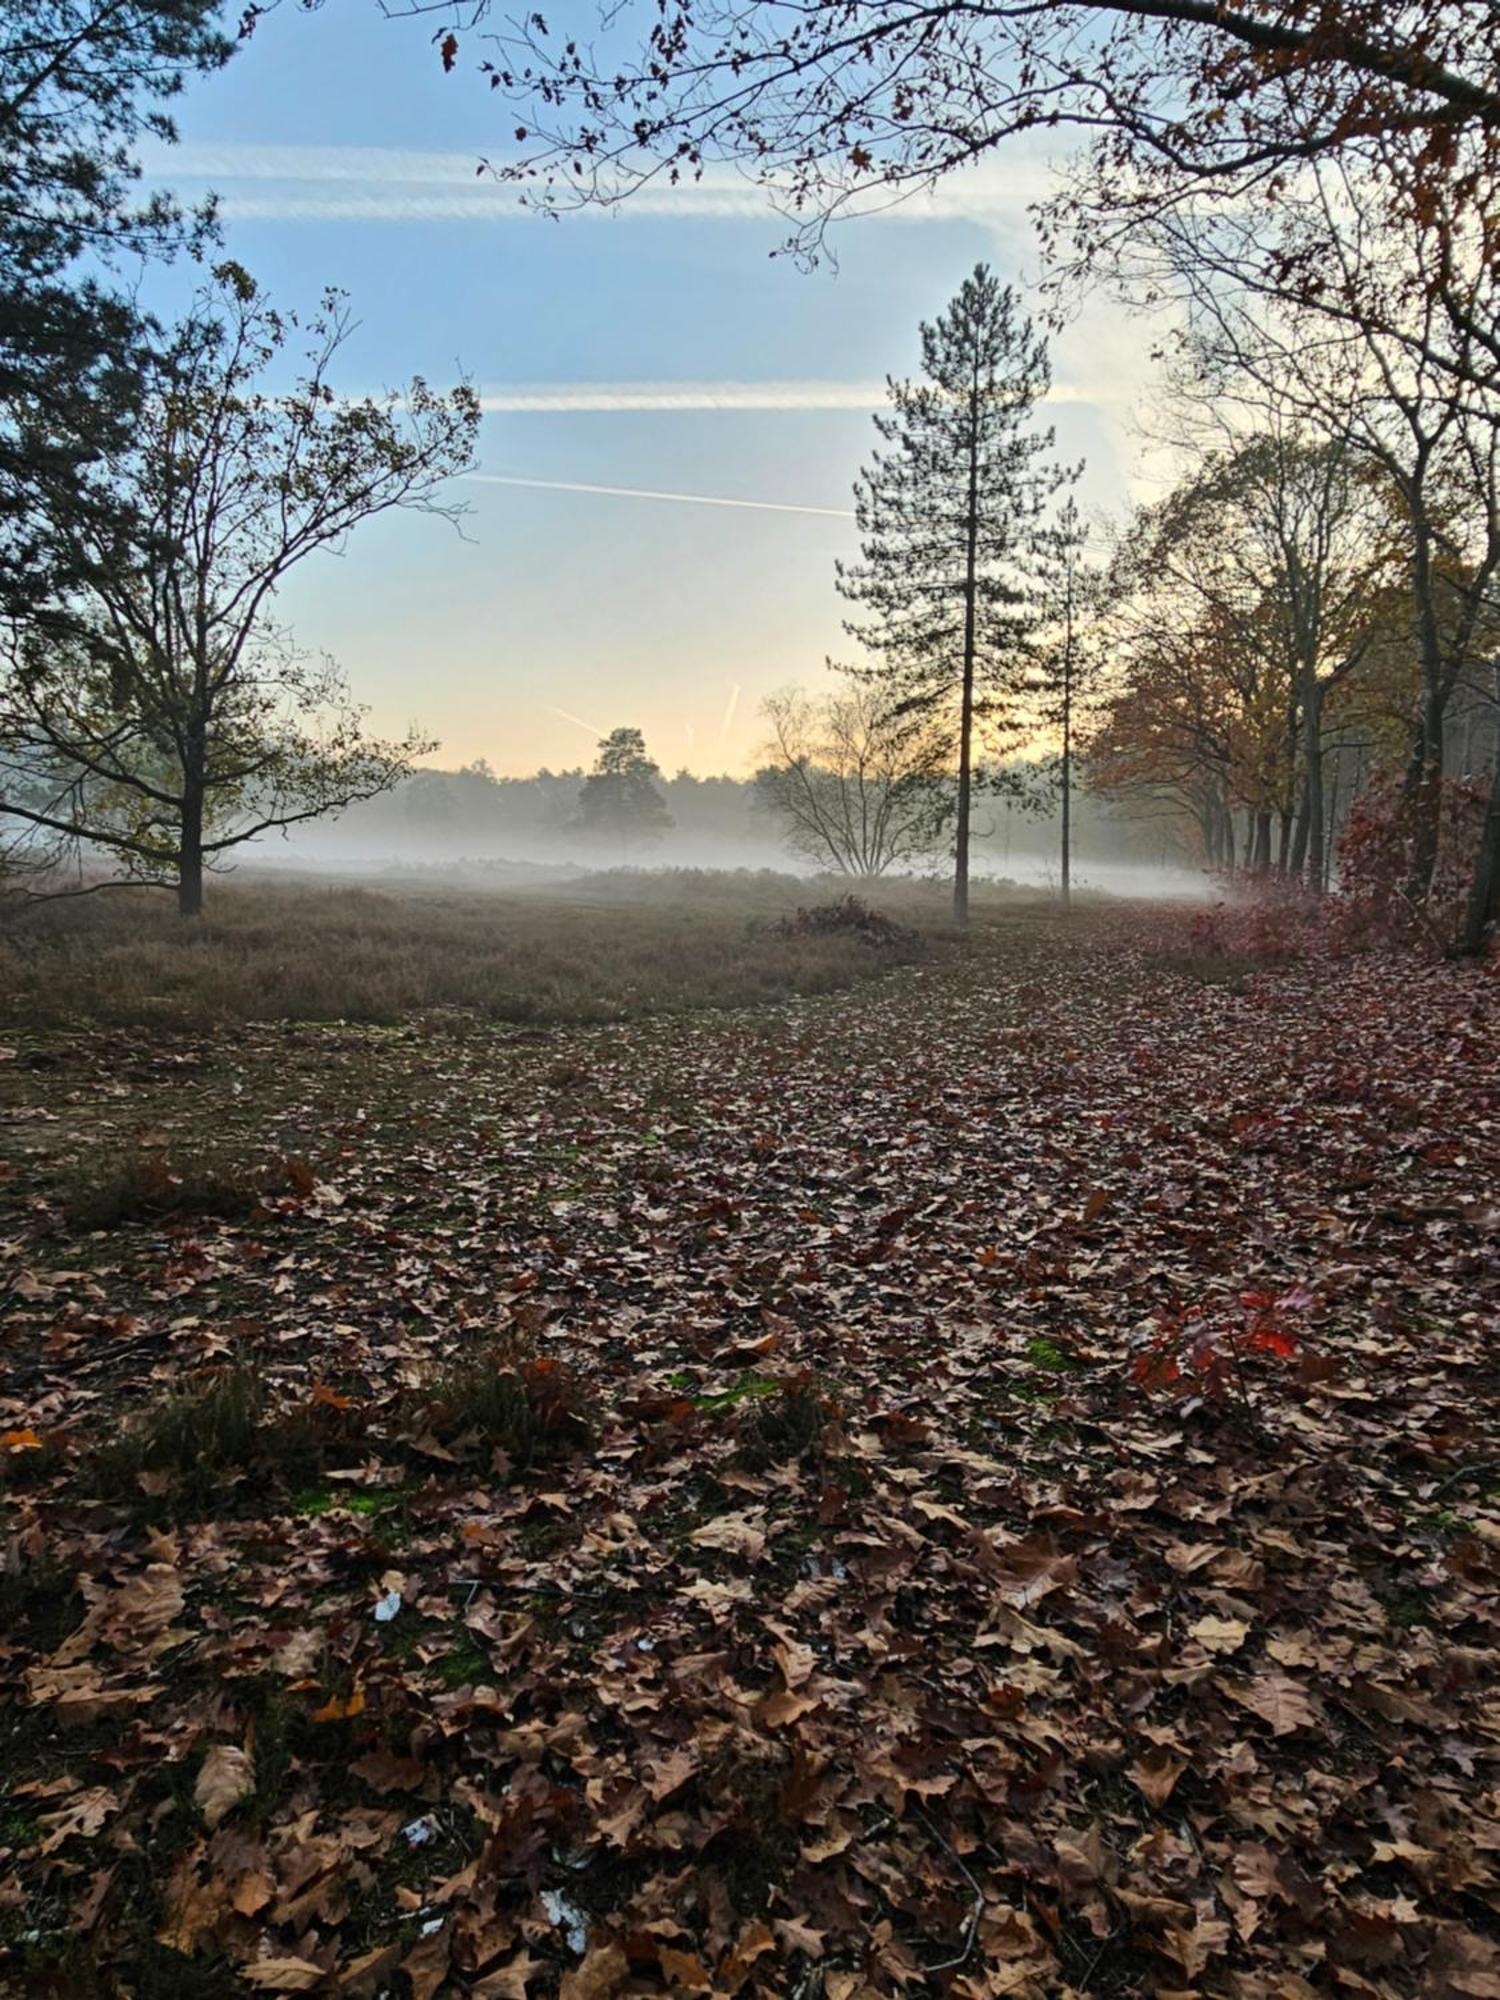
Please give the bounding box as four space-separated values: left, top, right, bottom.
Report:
144 0 1152 774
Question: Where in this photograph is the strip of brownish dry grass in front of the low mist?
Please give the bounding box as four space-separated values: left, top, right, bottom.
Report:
0 872 1014 1028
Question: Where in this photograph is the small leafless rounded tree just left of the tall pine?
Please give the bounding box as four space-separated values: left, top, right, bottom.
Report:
756 686 954 878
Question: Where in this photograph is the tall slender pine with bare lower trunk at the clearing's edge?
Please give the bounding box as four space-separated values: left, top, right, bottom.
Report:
838 264 1072 924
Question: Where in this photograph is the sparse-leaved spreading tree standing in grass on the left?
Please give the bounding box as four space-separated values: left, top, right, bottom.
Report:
0 266 478 916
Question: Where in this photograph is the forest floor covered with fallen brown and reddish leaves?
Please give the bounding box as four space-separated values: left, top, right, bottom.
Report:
0 908 1500 2000
